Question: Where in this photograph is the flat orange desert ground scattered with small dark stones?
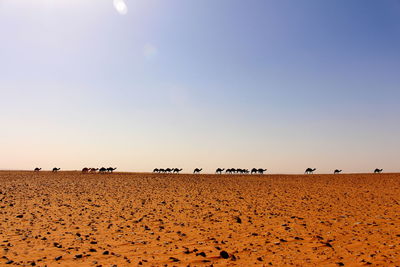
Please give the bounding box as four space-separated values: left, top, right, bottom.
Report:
0 171 400 266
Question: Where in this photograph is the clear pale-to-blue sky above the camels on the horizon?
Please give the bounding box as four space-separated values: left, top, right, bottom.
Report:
0 0 400 173
